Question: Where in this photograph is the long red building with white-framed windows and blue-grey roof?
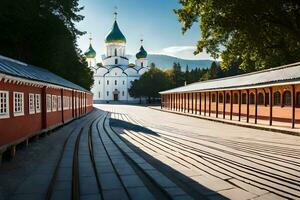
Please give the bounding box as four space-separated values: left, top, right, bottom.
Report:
0 56 93 160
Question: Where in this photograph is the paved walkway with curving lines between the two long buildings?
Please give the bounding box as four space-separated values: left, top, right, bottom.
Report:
0 105 300 200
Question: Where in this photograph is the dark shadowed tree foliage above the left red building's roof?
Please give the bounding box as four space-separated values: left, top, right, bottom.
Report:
0 0 93 89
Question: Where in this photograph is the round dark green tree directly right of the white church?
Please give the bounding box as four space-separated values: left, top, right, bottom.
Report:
129 67 171 102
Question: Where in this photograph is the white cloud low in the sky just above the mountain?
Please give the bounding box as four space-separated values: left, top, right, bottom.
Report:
153 46 214 60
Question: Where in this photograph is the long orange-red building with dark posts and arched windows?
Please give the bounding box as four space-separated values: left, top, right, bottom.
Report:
160 63 300 128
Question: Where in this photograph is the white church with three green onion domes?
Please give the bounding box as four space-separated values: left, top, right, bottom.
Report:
85 13 149 103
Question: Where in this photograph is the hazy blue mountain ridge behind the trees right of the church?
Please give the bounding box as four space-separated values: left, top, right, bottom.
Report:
147 54 213 71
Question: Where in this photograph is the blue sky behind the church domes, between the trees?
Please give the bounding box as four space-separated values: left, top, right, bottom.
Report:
77 0 211 61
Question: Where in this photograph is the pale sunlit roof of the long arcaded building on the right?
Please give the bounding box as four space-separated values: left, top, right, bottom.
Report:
160 62 300 94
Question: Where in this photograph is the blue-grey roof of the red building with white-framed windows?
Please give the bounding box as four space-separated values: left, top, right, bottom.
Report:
0 55 89 92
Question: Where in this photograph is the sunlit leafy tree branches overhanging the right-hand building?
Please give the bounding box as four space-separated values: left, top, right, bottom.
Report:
175 0 300 71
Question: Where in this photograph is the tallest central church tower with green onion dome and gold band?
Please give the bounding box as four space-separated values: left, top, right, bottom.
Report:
103 12 129 66
